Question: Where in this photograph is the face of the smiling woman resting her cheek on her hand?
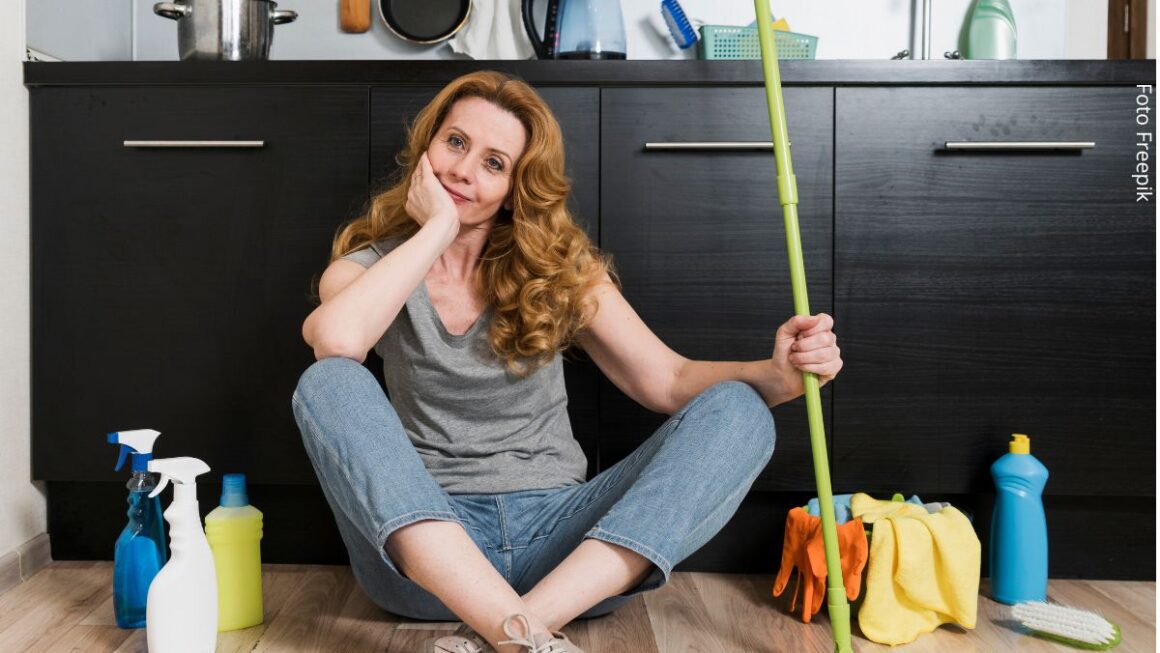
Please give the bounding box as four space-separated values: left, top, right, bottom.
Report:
427 97 528 226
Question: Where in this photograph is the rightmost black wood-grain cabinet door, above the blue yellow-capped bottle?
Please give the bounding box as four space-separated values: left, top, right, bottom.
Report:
834 87 1155 495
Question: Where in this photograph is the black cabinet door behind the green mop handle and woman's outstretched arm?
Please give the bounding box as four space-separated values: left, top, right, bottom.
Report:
601 88 833 489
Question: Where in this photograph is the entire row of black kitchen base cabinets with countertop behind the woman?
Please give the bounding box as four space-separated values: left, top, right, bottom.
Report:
24 60 1155 579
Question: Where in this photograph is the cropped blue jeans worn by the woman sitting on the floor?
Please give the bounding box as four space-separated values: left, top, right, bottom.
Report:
292 358 776 621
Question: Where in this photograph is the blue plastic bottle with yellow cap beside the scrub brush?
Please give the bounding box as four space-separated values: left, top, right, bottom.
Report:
991 433 1047 605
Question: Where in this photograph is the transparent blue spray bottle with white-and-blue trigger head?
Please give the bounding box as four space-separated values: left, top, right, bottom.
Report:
108 429 167 629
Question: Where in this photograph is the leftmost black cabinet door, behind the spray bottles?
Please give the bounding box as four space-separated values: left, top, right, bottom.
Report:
30 87 369 483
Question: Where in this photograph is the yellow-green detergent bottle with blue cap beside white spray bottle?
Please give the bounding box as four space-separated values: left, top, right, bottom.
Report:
205 474 262 632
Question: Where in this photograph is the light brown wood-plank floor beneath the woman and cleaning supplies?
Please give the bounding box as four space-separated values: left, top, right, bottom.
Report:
0 563 1157 653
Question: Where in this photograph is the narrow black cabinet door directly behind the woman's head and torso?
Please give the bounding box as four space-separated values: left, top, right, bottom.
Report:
370 87 600 476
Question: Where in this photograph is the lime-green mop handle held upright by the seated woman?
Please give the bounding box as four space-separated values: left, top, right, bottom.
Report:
754 0 854 653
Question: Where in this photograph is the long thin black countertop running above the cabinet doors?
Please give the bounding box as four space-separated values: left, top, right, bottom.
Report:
24 59 1157 87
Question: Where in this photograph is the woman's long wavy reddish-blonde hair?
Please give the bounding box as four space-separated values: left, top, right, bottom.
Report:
331 71 617 376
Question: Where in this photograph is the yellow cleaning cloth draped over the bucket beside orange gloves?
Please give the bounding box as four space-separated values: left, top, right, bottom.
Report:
850 493 981 646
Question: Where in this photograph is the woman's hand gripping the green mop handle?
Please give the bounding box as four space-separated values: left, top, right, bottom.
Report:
770 313 842 400
